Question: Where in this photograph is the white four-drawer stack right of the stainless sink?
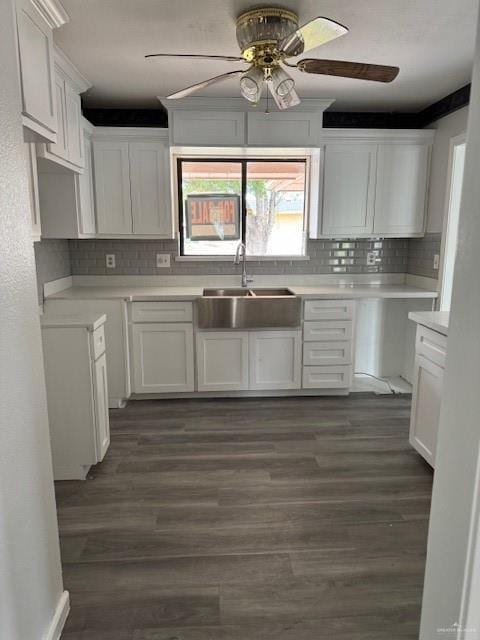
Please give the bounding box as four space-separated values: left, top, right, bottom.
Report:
302 299 355 390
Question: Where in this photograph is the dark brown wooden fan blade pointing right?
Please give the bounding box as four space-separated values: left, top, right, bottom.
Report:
297 58 400 82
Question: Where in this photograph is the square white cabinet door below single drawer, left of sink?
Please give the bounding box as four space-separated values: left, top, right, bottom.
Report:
132 322 194 393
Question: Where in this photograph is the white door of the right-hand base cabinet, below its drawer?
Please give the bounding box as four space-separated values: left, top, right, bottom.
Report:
410 355 444 467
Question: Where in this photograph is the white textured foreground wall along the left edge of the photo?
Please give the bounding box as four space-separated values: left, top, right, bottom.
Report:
0 0 63 640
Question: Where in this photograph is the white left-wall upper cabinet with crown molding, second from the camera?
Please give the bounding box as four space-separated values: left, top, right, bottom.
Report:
37 47 90 172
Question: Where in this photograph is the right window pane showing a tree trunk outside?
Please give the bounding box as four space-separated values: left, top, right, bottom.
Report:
246 160 306 256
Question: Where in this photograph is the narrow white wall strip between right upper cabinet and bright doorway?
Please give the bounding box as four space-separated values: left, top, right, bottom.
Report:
427 107 468 233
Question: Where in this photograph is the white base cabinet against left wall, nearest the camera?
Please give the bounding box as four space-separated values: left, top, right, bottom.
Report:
42 314 110 480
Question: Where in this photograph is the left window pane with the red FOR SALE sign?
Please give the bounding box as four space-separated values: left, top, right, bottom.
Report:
182 160 242 256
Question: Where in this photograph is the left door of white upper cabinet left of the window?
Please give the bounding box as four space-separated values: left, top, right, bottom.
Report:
93 140 132 235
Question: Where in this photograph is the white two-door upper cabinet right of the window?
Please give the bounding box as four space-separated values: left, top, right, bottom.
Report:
310 134 434 238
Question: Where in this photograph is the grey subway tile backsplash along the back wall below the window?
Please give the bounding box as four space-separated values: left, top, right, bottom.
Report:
69 239 408 275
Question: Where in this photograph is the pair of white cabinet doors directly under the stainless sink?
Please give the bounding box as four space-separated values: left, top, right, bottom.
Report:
196 330 302 391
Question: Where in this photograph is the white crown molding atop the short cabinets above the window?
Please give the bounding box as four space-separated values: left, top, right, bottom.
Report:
157 96 335 113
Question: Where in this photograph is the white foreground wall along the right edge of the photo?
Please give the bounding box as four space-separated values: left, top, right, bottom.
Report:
420 6 480 640
